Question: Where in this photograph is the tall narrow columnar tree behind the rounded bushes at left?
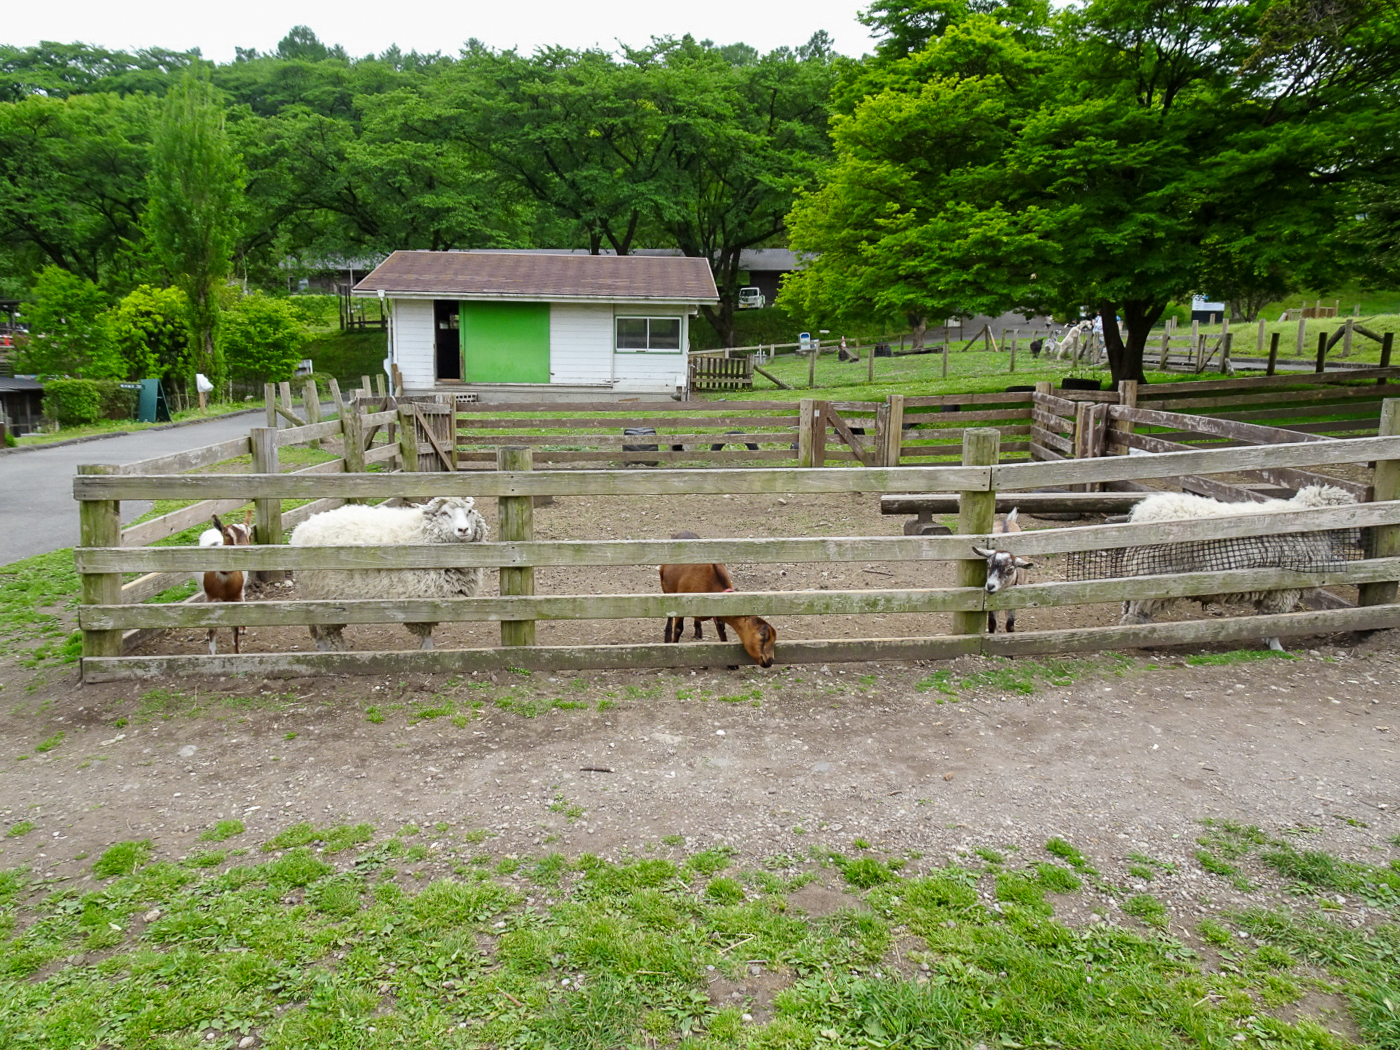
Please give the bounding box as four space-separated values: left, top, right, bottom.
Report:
143 73 245 386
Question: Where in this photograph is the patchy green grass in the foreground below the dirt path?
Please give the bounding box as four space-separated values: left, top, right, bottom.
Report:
0 825 1400 1050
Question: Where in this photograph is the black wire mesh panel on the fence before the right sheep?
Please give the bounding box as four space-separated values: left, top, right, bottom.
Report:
1064 529 1369 580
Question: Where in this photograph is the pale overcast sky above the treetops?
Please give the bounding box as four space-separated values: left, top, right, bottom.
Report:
10 0 872 62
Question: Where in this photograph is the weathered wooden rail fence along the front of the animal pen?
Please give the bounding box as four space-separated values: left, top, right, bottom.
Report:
74 400 1400 680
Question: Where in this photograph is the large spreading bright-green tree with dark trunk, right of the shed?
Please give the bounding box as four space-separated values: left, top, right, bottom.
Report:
790 0 1400 379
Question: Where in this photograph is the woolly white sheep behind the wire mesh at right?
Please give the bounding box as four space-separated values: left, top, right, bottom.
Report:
1121 484 1357 651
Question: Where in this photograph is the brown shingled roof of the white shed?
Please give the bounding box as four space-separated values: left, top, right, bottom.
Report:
354 252 720 302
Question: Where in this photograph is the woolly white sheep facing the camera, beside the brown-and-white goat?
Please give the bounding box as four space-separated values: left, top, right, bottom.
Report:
291 496 486 650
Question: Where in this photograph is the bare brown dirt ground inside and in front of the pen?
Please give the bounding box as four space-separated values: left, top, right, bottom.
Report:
0 494 1400 939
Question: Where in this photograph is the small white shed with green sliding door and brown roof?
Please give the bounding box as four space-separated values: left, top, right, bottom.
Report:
353 252 720 400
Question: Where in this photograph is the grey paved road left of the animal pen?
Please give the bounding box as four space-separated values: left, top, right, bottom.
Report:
0 406 270 566
